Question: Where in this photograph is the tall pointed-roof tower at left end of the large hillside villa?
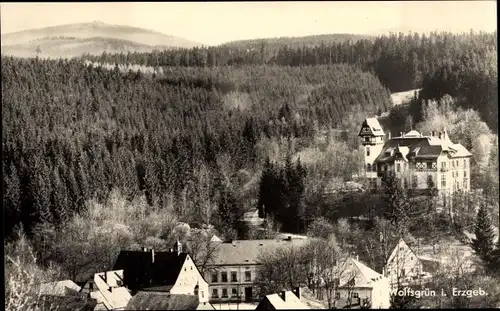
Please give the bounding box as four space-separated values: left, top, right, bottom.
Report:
358 118 385 182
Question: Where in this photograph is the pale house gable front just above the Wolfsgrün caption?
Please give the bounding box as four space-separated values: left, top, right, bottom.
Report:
384 238 423 289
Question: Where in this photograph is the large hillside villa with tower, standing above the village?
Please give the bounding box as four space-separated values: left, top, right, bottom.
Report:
358 118 472 199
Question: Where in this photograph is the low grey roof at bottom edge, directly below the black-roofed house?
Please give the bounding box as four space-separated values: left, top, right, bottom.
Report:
125 292 200 310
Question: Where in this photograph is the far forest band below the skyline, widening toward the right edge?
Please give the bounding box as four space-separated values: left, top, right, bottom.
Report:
84 31 498 131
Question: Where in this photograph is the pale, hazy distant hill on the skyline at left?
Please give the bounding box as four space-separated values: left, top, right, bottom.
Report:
2 22 201 57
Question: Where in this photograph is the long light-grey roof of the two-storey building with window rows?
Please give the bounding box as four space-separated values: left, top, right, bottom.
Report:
210 239 307 265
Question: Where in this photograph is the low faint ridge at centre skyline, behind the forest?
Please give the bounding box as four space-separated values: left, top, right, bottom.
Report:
222 34 375 49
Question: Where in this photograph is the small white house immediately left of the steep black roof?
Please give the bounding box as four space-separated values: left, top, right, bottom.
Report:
80 270 132 311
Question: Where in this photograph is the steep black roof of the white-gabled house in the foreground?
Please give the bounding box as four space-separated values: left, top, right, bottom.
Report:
113 251 187 291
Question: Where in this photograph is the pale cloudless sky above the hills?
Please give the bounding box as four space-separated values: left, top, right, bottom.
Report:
0 0 497 44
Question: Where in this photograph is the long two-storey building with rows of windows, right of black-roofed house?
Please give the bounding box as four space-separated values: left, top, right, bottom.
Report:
205 237 307 303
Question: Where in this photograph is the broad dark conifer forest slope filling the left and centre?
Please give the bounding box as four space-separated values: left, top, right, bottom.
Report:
1 57 391 239
